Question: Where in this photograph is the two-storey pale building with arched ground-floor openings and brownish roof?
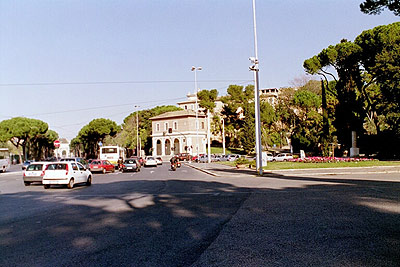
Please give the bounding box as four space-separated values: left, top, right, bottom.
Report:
150 108 207 156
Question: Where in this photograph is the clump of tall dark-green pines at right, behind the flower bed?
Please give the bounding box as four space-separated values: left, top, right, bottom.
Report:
303 22 400 157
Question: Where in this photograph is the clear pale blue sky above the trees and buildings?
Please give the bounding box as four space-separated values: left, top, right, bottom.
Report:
0 0 399 139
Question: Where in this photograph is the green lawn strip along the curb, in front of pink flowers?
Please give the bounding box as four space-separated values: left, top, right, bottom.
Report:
220 160 400 170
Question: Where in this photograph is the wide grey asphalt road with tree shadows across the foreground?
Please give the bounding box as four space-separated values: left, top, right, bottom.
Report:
0 165 400 266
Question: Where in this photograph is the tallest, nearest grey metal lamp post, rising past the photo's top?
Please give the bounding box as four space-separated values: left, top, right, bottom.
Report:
249 0 263 176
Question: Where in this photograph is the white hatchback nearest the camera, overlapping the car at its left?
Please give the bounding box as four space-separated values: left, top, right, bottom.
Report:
42 161 92 189
